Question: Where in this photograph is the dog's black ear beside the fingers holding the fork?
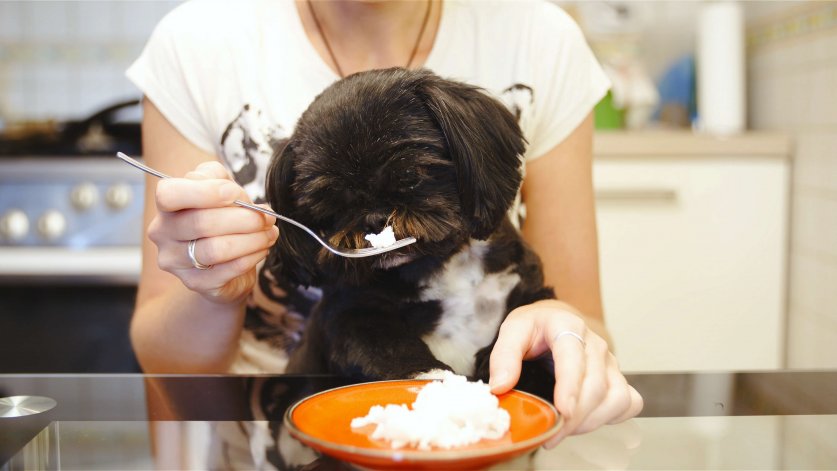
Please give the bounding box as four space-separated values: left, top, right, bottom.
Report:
265 141 320 286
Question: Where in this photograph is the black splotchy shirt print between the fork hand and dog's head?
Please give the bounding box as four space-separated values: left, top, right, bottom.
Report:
221 104 288 203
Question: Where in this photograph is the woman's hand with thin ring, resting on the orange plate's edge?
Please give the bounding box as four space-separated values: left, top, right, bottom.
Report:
490 300 643 448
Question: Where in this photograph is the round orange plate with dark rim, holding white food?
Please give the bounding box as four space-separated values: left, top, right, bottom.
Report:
285 380 561 469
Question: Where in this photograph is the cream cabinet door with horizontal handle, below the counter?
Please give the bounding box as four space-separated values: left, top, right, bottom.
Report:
594 157 788 371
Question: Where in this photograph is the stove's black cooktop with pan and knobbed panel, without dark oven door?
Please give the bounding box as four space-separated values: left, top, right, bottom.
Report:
0 100 144 284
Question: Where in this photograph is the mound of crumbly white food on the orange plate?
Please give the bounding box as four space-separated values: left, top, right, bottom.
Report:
352 372 510 450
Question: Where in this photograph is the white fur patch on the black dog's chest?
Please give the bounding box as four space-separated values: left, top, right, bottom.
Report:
421 241 520 375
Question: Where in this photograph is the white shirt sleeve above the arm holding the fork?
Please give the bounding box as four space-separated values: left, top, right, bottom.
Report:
125 2 215 154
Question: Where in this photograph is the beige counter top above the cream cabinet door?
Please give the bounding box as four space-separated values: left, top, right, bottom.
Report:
593 130 793 158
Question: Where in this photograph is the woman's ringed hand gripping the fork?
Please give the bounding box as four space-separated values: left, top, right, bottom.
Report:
148 162 279 303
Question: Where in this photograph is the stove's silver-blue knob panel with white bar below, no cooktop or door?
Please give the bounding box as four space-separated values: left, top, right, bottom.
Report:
0 156 144 283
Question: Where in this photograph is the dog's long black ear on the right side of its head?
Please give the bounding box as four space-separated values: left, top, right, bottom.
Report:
419 74 526 243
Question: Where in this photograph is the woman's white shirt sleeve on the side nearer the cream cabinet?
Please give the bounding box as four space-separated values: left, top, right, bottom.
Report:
526 2 610 161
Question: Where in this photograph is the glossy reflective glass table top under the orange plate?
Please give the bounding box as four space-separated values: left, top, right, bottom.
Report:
0 371 837 471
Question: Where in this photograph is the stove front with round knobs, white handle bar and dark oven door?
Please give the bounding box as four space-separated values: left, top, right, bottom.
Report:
0 157 143 373
